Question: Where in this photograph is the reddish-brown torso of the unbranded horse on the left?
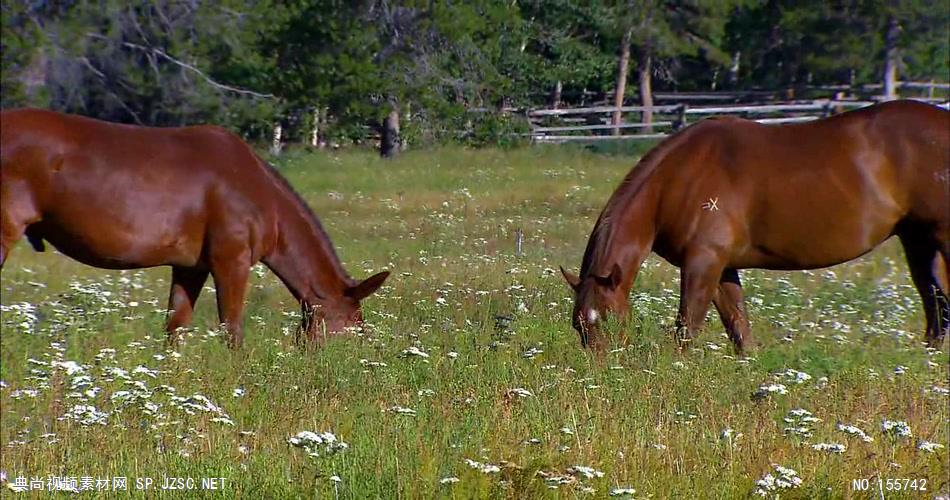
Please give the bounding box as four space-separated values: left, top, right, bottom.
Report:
0 109 277 268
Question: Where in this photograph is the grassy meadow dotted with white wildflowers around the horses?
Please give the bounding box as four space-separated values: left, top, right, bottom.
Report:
0 148 950 499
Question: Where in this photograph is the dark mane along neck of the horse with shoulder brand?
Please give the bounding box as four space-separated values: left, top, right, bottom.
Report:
580 126 692 279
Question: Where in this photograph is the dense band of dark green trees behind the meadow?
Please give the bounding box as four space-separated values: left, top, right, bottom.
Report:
2 0 950 143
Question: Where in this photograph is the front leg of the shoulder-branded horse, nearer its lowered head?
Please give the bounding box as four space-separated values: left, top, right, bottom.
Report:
675 251 724 348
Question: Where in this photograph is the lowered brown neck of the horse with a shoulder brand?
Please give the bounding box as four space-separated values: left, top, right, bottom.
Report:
581 176 658 293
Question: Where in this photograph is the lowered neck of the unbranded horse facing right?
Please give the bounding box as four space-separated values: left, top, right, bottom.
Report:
262 197 352 305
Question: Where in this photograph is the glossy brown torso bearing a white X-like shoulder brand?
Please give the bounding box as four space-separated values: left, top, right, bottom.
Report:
654 101 950 269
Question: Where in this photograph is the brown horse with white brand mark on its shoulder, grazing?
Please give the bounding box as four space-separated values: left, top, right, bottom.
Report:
561 101 950 351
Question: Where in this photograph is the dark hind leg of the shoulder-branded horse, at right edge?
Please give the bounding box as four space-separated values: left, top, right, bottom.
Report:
901 235 950 347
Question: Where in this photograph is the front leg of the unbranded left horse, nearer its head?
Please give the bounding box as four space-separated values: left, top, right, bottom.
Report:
211 254 251 349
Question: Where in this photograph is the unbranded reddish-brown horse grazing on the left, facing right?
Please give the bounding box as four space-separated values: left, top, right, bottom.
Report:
0 109 389 347
